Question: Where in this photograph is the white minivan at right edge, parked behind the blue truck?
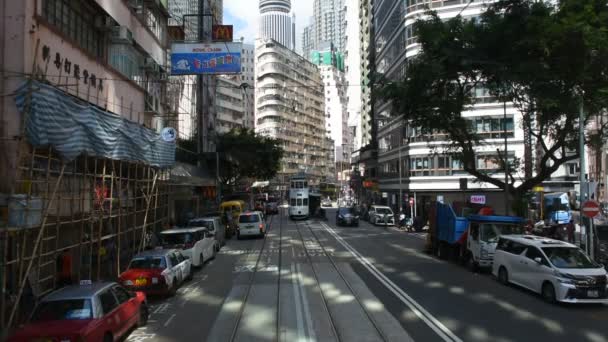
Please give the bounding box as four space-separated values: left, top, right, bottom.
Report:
492 235 608 303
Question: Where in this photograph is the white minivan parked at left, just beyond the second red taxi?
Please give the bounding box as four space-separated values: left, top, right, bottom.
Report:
160 227 216 267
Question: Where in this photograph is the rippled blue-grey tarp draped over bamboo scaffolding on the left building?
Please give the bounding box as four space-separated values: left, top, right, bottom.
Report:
15 81 175 168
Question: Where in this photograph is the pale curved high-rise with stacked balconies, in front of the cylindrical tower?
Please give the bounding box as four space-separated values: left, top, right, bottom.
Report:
255 39 333 186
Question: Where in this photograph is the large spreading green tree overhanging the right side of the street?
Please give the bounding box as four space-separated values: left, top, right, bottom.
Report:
379 0 608 198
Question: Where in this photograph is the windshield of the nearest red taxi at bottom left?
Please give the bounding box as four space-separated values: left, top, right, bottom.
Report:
32 299 93 322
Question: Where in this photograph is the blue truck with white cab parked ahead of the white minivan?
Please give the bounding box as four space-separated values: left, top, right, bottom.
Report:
430 202 525 270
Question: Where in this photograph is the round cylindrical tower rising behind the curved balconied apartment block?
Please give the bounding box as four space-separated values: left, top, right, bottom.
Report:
258 0 295 50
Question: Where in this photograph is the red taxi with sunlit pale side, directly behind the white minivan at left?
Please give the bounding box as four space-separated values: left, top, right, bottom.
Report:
119 249 193 295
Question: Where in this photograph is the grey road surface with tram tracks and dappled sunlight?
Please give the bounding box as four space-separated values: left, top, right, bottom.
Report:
128 210 608 342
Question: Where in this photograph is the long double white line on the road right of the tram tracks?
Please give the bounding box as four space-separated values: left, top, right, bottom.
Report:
320 222 462 342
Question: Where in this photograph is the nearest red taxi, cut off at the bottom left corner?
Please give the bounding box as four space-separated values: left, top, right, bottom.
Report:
8 282 148 342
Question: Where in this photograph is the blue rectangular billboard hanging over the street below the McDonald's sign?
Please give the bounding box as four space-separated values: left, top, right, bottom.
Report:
171 43 242 75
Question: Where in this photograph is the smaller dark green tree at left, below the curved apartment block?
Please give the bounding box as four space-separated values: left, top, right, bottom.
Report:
217 129 283 186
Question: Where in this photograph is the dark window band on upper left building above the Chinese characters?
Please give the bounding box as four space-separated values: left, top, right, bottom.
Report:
42 0 105 59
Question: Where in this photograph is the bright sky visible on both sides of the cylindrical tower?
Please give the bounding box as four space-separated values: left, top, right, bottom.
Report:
224 0 313 51
